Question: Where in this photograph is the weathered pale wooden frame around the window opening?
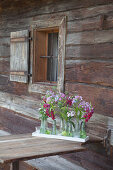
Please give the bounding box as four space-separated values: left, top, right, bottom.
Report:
28 16 66 93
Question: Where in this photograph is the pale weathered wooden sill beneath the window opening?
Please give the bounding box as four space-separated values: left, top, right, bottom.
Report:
28 82 57 94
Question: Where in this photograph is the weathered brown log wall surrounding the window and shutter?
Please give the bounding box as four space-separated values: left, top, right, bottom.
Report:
0 0 113 142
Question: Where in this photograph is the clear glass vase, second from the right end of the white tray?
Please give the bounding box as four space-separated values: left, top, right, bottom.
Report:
73 120 81 138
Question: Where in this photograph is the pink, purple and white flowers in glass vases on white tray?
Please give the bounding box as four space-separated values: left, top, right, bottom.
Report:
39 91 94 138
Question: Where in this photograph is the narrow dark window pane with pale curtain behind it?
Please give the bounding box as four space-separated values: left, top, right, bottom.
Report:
47 33 58 81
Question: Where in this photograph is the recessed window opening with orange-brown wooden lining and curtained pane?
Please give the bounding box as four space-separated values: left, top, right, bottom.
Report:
33 28 58 83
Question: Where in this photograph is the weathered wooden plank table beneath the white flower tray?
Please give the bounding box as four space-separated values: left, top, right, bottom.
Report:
0 134 85 170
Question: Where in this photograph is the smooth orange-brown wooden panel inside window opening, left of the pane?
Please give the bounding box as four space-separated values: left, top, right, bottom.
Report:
33 30 47 82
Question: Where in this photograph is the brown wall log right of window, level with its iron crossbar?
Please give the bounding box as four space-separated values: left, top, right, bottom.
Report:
66 43 113 60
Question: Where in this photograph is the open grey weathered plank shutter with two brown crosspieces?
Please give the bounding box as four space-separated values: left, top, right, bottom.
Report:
10 30 29 83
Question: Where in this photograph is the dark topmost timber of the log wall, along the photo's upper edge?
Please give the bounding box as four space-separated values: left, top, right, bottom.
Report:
1 0 112 18
